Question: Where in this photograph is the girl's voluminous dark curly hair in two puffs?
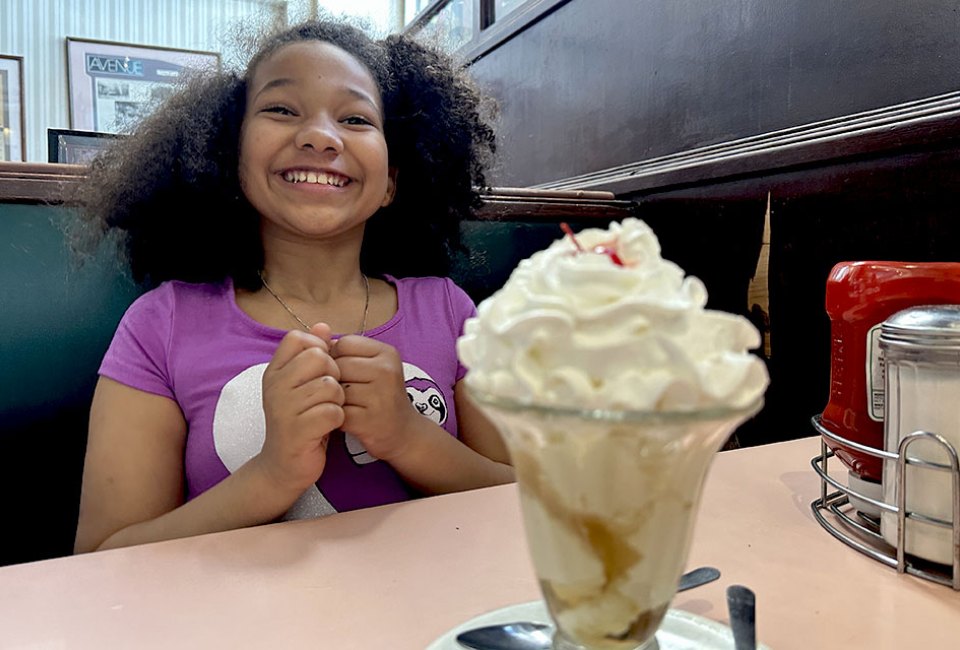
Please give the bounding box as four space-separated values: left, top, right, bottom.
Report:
70 20 496 290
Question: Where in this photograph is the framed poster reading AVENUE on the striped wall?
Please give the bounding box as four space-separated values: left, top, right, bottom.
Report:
67 37 220 133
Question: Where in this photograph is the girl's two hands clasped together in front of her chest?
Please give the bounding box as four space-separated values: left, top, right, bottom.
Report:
258 323 422 491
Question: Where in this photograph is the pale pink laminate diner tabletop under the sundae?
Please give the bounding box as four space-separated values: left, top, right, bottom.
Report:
0 438 960 650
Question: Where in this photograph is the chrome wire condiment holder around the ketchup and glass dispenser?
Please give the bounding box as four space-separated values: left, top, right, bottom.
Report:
810 415 960 591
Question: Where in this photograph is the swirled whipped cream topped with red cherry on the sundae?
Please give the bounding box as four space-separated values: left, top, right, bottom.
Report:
457 218 769 411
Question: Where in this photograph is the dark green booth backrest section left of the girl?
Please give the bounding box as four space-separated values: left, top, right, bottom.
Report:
0 203 139 564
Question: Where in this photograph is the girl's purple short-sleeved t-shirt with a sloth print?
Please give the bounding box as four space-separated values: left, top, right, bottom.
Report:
100 276 476 518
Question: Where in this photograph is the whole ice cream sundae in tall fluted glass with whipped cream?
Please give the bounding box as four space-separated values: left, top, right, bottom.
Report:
458 219 768 650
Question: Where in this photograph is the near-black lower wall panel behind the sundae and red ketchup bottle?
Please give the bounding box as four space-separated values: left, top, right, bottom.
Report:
631 143 960 446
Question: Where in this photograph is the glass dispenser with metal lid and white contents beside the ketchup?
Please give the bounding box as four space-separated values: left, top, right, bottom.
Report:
880 305 960 565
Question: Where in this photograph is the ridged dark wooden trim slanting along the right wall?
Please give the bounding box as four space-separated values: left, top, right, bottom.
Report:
533 92 960 196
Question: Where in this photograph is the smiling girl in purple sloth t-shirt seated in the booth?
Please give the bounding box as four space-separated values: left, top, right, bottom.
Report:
75 22 513 552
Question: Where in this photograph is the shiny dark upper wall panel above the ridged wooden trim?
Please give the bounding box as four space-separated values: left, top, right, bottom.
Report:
472 0 960 191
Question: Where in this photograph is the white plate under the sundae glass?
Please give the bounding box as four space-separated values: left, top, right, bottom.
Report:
427 600 770 650
